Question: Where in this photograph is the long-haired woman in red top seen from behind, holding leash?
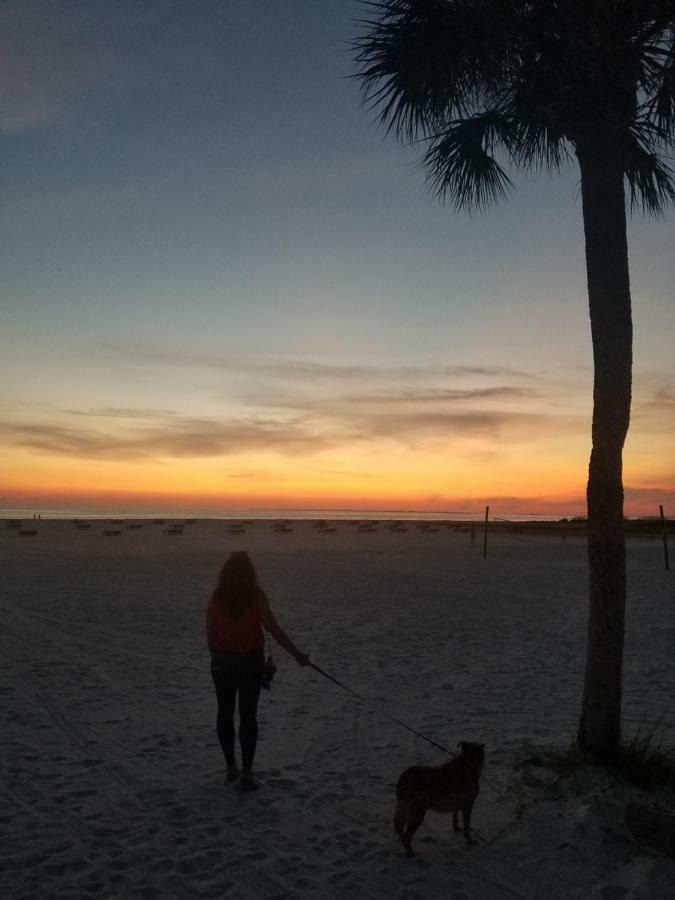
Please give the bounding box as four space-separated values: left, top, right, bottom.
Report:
206 551 309 791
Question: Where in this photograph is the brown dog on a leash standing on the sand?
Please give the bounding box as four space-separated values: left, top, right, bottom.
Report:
394 741 485 856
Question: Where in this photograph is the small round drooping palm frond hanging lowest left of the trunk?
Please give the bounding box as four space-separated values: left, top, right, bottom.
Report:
422 110 514 210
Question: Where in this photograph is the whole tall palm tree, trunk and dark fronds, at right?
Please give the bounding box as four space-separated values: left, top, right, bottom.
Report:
356 0 675 760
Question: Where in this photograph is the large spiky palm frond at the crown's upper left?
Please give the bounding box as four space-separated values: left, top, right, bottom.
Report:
353 0 508 141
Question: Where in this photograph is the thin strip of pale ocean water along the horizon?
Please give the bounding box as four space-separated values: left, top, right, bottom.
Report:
0 507 561 522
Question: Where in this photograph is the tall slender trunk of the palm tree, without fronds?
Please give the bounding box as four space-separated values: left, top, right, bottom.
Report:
576 141 633 761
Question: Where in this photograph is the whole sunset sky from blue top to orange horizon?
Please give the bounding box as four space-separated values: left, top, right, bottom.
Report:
0 0 675 517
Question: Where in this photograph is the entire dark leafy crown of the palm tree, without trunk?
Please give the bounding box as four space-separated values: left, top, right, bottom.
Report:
354 0 675 215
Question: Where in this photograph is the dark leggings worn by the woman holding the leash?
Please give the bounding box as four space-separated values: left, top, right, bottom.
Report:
211 650 264 769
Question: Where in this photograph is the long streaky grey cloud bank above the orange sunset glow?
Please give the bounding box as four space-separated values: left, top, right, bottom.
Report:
4 345 587 460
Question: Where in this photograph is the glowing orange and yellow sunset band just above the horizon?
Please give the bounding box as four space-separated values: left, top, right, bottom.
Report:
3 376 675 516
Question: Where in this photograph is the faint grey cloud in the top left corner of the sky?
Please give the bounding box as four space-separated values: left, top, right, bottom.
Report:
0 0 224 133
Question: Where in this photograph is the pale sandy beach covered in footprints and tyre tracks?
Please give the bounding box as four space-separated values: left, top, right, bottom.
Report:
0 520 675 900
